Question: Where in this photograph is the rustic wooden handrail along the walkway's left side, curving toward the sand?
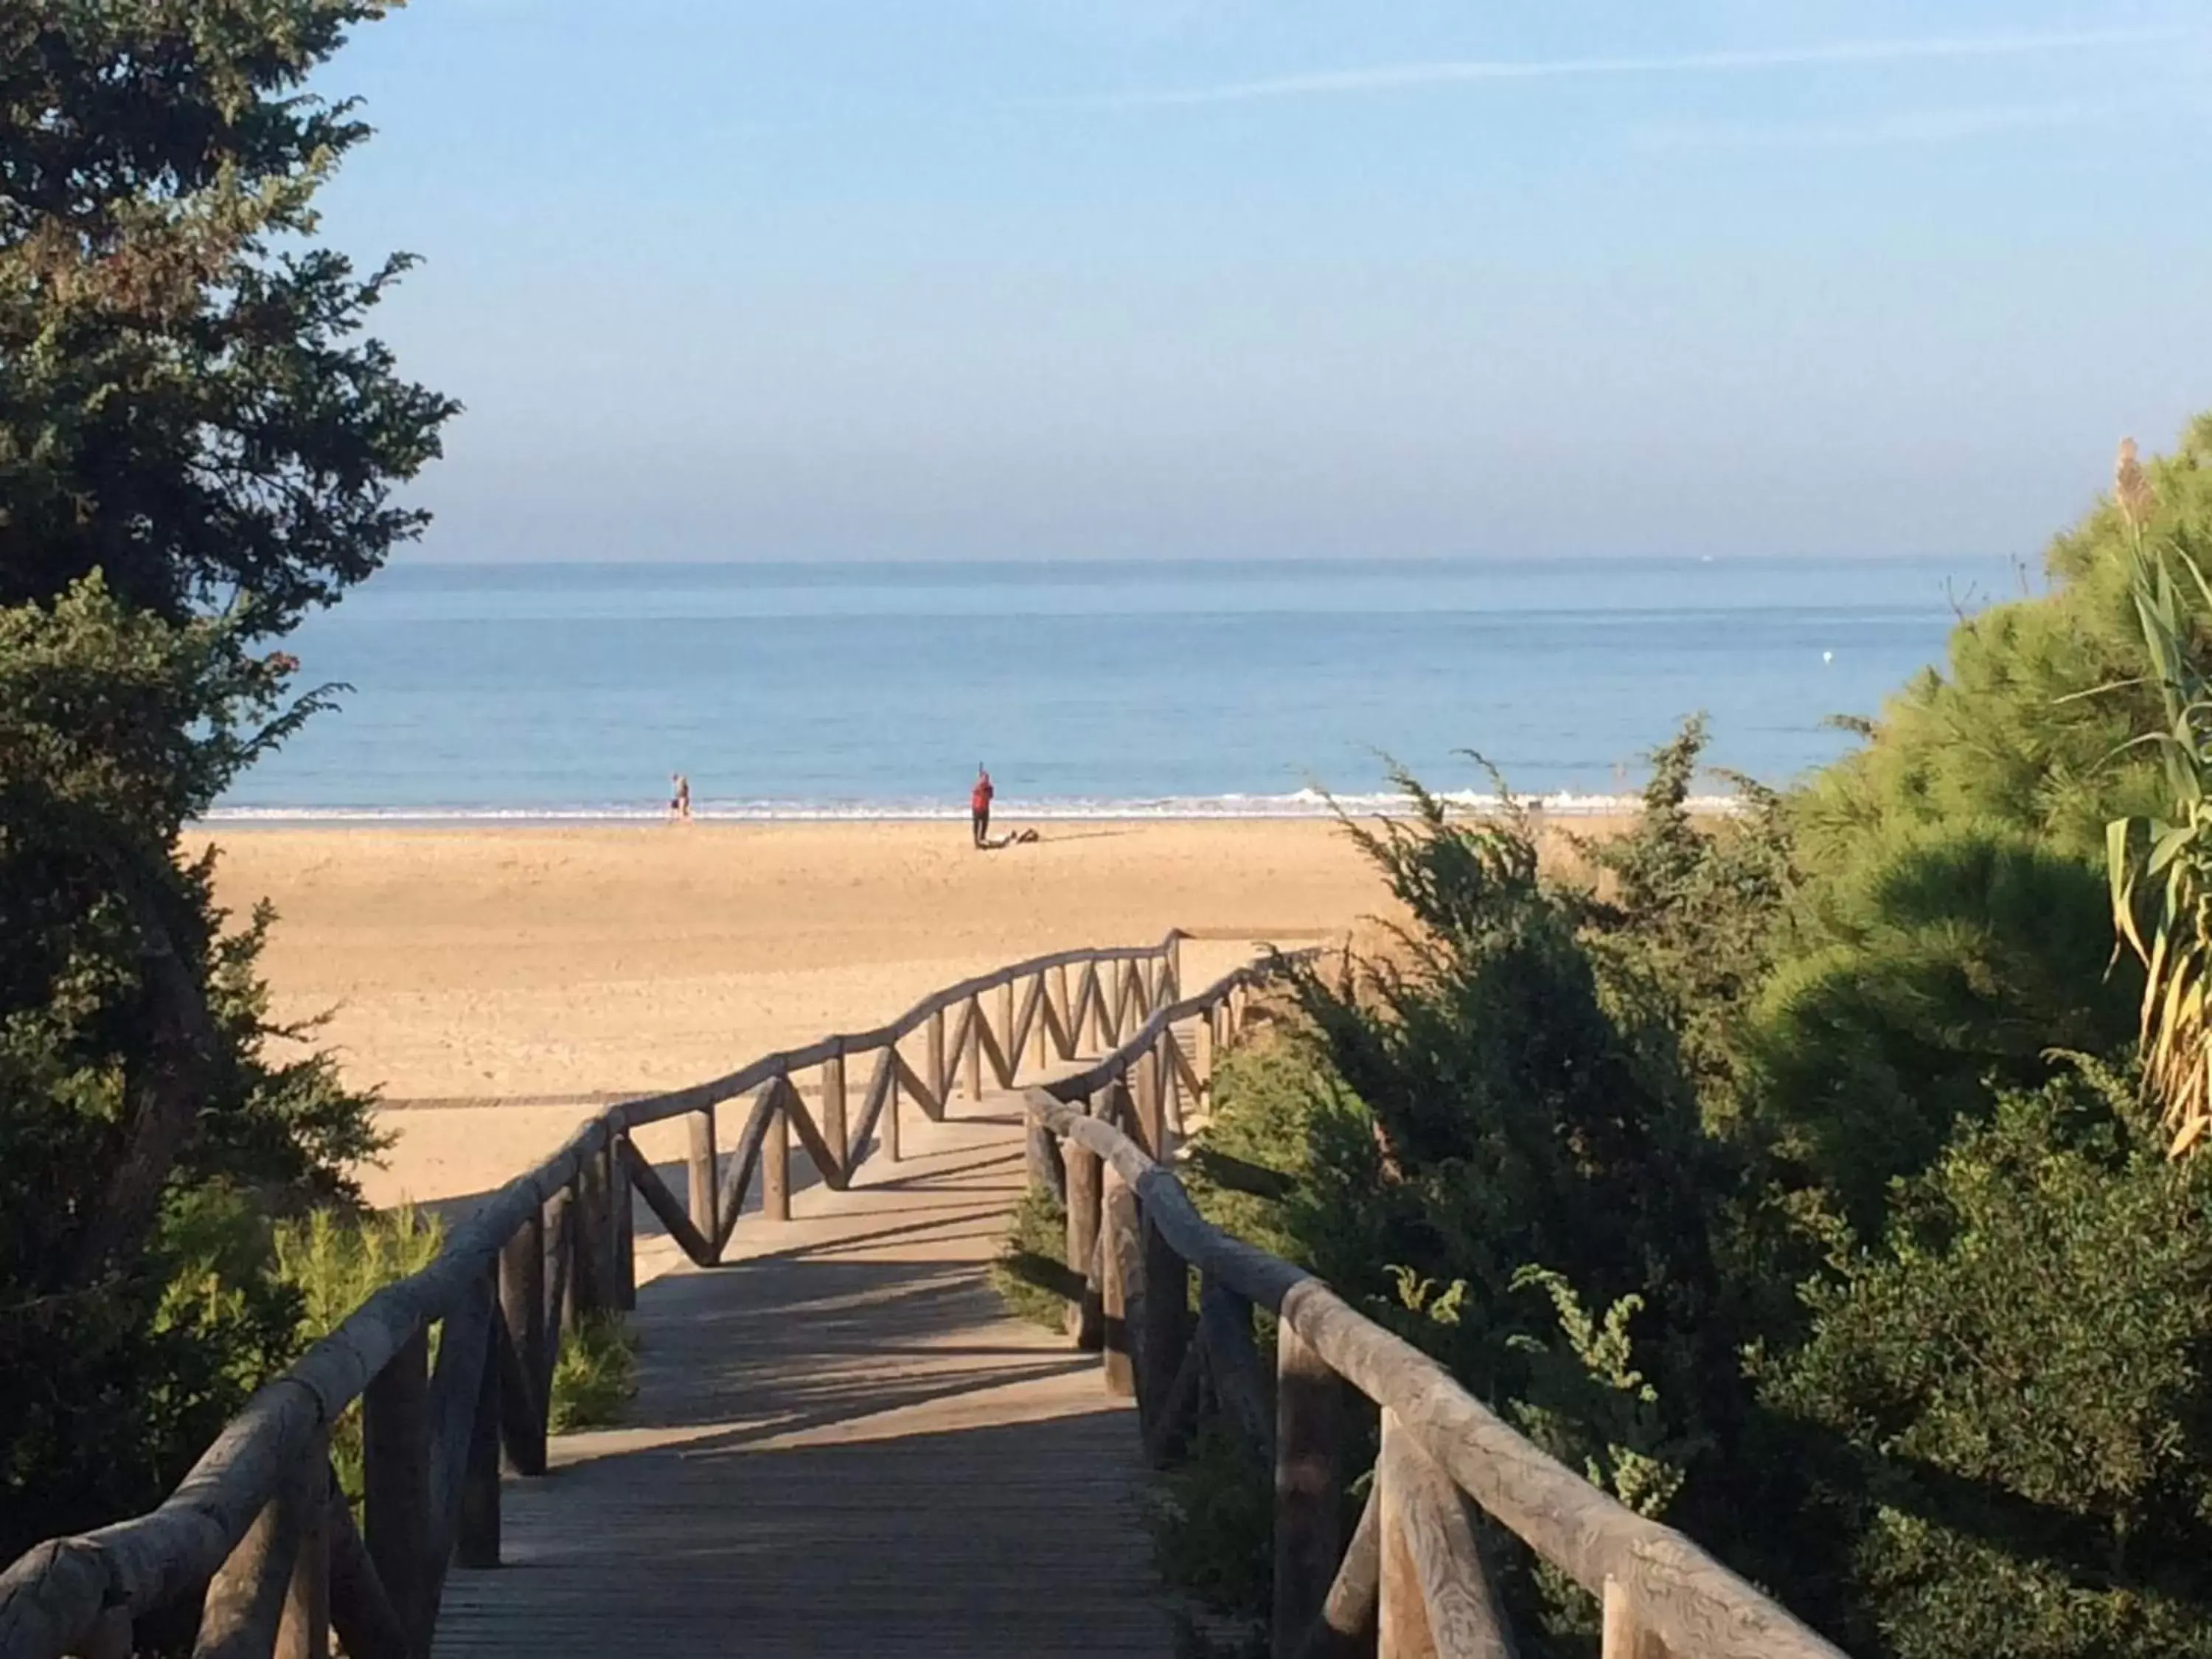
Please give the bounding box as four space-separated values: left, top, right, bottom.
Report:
0 931 1256 1659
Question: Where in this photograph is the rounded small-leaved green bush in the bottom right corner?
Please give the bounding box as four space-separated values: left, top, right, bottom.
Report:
1767 1068 2212 1659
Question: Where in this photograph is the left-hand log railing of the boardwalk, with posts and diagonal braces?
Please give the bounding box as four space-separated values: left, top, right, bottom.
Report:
0 933 1265 1659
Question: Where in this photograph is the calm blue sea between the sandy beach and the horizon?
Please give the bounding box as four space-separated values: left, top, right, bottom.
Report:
221 560 2017 816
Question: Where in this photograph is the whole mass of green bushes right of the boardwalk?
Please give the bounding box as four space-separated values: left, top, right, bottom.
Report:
1009 418 2212 1659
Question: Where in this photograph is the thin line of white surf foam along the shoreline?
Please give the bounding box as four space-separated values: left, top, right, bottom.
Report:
206 790 1741 825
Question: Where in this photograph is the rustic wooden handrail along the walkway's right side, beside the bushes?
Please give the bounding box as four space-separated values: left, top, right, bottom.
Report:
1026 1013 1843 1659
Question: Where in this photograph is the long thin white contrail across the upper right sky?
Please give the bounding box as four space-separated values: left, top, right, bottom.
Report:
1099 29 2197 106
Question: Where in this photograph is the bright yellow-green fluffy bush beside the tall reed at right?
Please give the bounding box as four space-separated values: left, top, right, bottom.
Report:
1747 416 2212 1232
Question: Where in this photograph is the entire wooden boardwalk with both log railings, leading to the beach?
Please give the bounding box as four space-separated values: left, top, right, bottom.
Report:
0 936 1845 1659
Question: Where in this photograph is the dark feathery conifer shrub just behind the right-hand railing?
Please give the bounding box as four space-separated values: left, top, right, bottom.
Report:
1287 781 1734 1442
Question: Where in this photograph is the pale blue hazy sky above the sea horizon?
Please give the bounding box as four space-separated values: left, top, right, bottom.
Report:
321 0 2212 560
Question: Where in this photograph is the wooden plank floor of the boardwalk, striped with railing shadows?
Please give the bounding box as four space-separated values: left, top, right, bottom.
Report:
420 1095 1172 1659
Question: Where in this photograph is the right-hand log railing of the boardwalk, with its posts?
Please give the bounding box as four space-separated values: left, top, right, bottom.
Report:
1026 995 1843 1659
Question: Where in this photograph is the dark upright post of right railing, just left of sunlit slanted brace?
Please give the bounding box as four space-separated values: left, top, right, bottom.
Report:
1272 1321 1343 1659
